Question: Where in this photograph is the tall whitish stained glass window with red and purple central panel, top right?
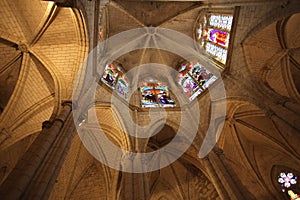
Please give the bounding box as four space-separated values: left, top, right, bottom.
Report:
196 13 233 65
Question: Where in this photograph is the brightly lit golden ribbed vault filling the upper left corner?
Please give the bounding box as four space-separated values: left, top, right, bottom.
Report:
0 0 87 150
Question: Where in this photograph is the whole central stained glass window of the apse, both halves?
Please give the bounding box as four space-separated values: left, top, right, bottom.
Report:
140 82 176 108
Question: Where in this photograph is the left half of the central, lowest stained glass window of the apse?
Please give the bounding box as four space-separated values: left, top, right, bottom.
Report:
141 83 158 107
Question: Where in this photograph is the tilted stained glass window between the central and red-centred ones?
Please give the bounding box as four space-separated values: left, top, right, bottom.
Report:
178 62 217 101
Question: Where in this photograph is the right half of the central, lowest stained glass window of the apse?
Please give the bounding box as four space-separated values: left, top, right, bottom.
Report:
155 83 175 107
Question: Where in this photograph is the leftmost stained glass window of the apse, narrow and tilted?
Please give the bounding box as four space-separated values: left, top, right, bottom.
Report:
101 64 129 100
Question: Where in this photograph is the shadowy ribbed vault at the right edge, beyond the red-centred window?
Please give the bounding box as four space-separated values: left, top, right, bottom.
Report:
245 14 300 99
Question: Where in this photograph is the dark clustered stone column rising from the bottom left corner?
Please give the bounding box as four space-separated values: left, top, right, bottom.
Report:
0 102 75 199
